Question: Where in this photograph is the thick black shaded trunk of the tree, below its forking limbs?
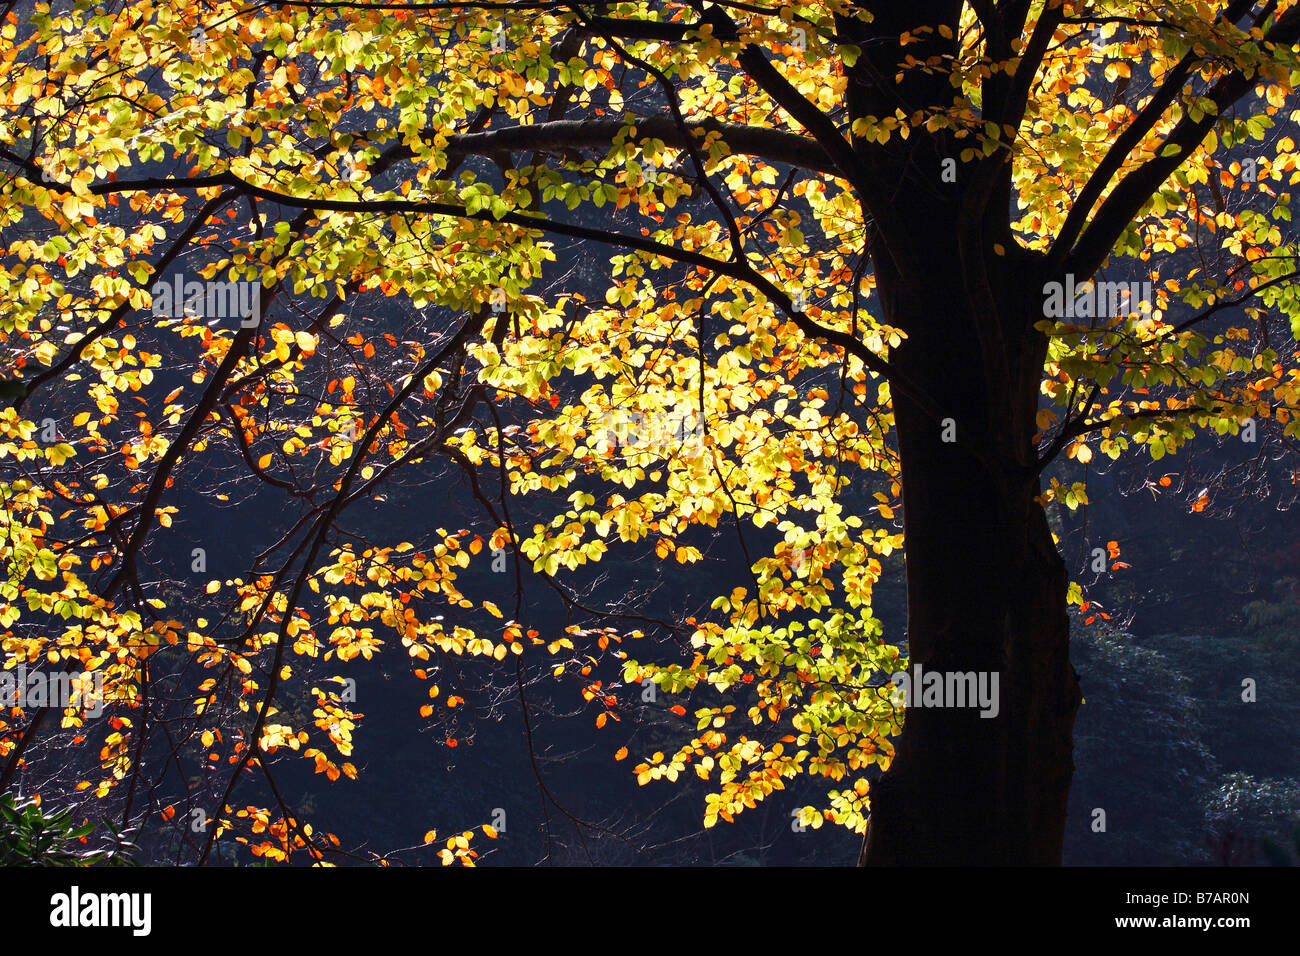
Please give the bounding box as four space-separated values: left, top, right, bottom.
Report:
861 226 1080 866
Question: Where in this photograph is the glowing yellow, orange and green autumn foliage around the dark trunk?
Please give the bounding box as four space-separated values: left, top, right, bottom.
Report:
0 0 1300 862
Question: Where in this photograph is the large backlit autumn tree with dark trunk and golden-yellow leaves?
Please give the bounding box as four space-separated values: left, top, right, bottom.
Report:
0 0 1300 864
